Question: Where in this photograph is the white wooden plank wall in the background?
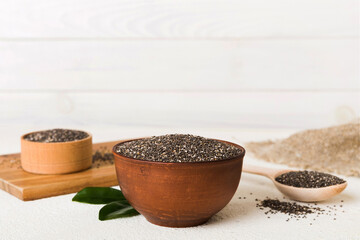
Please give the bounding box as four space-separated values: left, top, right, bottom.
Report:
0 0 360 128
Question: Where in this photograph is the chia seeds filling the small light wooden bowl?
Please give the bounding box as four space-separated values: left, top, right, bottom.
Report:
24 128 89 143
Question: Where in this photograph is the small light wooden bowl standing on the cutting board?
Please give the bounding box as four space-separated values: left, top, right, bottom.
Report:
21 133 92 174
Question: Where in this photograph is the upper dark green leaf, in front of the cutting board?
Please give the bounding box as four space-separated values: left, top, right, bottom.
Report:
72 187 126 204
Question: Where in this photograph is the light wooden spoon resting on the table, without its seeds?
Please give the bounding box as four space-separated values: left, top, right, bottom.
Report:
242 165 347 202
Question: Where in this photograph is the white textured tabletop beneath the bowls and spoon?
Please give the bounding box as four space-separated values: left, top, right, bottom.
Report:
0 125 360 240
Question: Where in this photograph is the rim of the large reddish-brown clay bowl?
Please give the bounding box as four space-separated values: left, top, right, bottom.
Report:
112 137 246 165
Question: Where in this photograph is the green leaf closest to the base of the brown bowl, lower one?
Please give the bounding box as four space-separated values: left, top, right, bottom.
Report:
99 200 140 221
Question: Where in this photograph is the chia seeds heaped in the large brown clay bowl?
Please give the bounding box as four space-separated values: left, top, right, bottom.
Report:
115 134 243 162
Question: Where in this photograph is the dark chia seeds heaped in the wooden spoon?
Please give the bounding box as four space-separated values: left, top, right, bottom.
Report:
275 171 346 188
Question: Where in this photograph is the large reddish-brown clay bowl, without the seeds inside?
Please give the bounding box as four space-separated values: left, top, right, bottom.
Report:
113 140 245 227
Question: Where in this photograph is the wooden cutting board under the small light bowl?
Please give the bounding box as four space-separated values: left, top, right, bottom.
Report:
0 140 124 201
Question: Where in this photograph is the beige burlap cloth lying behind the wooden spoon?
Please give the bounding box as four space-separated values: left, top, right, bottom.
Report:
246 123 360 177
